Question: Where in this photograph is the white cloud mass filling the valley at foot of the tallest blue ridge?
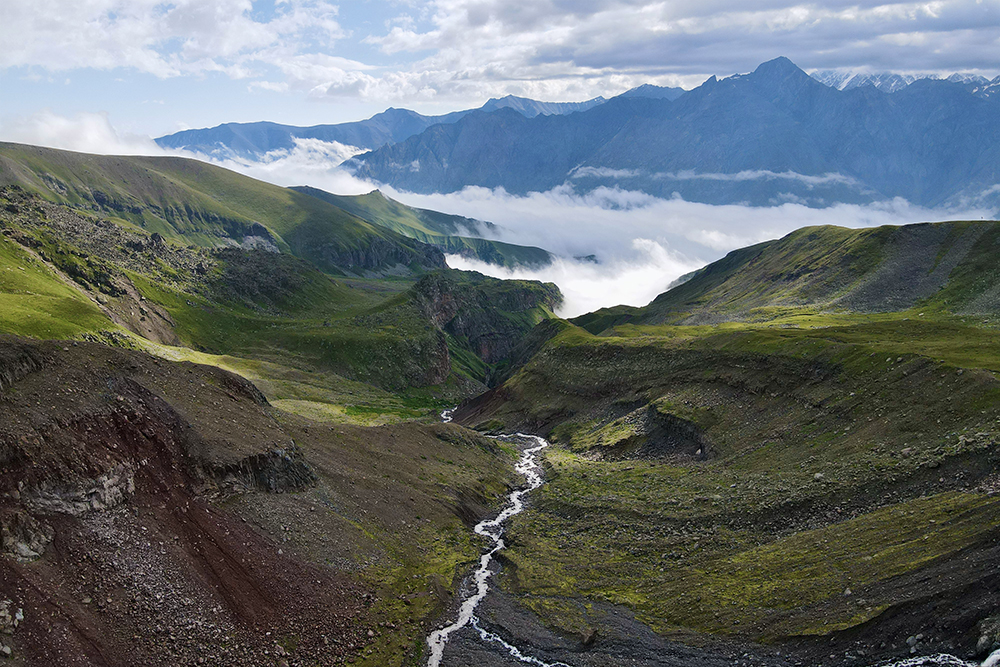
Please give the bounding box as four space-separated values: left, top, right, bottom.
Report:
386 186 995 317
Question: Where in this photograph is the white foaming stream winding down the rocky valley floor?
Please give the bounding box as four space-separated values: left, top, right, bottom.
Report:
427 410 569 667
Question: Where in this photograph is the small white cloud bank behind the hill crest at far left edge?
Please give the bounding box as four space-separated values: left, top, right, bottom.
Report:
0 110 166 155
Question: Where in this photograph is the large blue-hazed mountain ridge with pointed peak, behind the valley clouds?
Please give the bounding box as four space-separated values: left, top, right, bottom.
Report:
346 58 1000 207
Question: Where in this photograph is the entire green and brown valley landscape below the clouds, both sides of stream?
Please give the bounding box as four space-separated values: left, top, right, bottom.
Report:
0 142 1000 667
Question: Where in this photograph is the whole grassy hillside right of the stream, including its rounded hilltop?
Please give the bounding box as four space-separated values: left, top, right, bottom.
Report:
458 218 1000 664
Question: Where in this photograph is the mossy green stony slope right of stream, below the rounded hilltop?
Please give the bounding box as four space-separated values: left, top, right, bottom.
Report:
459 320 1000 664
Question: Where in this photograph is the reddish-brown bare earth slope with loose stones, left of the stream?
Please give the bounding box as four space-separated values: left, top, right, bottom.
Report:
0 336 506 666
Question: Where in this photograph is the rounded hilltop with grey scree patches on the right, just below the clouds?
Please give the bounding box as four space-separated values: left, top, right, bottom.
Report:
574 221 1000 333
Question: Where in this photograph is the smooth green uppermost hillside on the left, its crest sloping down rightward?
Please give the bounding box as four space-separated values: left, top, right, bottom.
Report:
0 143 444 273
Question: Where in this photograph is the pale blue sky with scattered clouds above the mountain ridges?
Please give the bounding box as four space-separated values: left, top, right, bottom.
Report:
0 0 1000 139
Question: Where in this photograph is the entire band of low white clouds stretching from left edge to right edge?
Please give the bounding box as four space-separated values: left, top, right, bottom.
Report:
0 112 996 317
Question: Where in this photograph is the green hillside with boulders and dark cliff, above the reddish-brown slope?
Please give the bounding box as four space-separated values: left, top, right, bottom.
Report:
0 188 560 423
